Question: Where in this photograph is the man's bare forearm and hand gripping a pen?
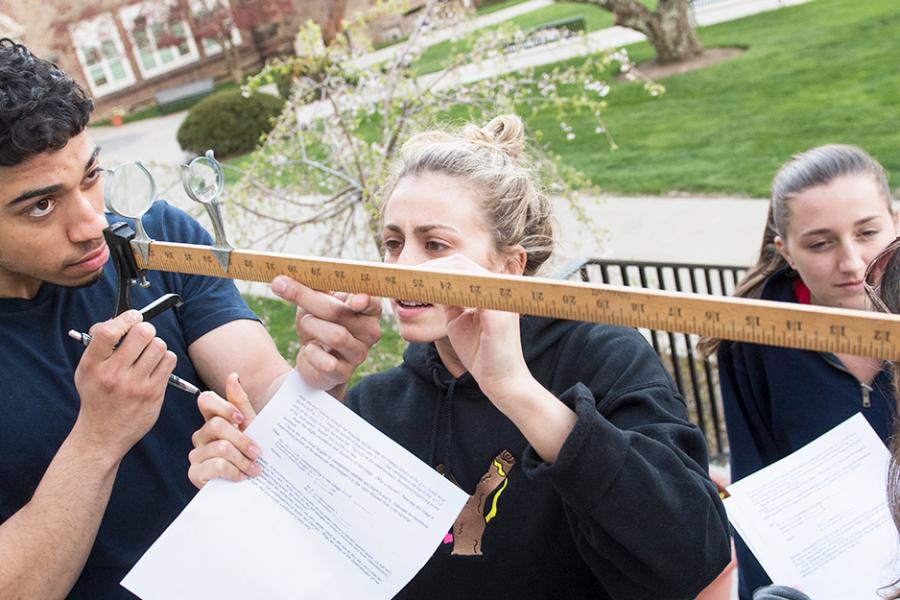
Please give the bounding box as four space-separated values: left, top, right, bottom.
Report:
0 311 176 599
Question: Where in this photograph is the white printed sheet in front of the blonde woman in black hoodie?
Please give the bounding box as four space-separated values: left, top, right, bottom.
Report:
122 371 468 600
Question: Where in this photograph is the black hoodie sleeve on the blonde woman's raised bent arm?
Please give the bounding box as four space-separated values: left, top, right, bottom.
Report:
523 326 731 599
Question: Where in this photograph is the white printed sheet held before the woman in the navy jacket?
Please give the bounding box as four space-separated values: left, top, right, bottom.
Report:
725 413 900 600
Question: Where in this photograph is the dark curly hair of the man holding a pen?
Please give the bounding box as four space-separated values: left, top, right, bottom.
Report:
0 38 94 167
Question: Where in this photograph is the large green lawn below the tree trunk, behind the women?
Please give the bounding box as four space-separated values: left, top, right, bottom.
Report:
529 0 900 197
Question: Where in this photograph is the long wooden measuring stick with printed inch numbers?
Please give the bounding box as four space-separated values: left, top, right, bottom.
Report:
135 241 900 360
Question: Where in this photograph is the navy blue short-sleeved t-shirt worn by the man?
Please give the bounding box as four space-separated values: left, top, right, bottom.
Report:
0 202 256 600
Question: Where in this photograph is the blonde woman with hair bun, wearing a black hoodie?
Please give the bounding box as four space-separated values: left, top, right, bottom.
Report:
190 115 730 600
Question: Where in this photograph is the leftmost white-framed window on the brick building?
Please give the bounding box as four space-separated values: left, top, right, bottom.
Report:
69 13 135 96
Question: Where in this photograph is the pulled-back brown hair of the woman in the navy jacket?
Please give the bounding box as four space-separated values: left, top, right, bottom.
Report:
697 144 894 356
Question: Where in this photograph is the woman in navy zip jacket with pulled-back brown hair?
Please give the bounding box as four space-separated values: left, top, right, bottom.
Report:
702 145 897 600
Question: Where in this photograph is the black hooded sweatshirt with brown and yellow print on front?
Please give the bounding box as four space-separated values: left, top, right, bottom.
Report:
348 317 730 600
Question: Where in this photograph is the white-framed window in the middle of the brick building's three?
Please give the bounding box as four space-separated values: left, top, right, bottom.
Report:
119 2 200 78
